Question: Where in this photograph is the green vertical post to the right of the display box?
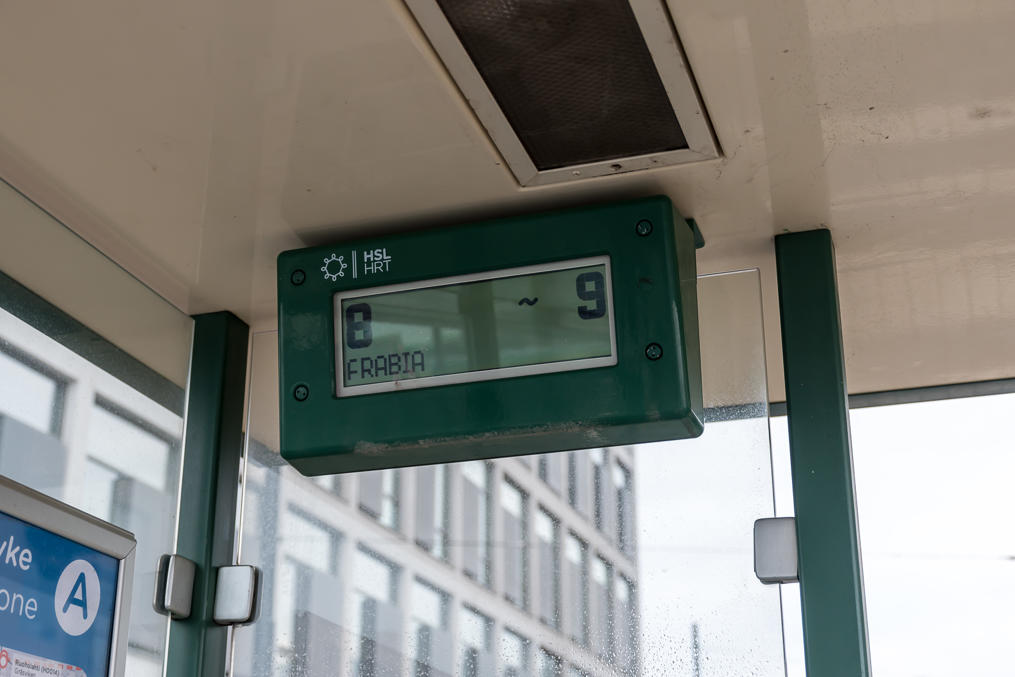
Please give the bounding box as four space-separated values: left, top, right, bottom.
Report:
775 229 870 677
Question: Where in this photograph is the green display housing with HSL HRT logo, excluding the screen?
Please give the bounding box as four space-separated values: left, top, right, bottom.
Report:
277 197 703 475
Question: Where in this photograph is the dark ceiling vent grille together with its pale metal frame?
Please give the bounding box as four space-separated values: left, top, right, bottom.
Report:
406 0 718 186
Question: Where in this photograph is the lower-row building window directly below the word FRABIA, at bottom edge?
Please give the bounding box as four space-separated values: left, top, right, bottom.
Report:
350 547 402 677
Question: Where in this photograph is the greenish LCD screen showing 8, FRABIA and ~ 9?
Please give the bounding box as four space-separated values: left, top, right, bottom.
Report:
335 257 617 397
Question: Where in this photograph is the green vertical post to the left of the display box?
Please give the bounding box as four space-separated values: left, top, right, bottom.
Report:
164 313 249 677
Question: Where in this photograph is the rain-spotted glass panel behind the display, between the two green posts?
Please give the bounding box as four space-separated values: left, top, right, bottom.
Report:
230 272 784 677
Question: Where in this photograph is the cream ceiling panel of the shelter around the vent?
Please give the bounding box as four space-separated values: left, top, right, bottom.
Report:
0 0 1015 399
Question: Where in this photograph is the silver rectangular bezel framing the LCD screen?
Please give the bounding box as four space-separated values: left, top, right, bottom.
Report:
333 256 617 398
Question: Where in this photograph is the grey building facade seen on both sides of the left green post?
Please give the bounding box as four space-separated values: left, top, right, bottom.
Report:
0 304 638 677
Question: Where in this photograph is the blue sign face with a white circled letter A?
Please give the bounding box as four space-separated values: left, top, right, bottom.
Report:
0 513 120 677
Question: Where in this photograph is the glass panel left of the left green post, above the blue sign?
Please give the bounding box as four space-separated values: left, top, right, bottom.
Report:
0 182 192 677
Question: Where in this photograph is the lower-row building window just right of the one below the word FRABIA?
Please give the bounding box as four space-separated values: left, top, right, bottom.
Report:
409 579 452 677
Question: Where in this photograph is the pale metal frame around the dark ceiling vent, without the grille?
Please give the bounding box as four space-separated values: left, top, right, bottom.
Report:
404 0 720 187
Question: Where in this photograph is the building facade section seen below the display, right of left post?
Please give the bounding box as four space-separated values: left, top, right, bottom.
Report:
233 432 637 677
